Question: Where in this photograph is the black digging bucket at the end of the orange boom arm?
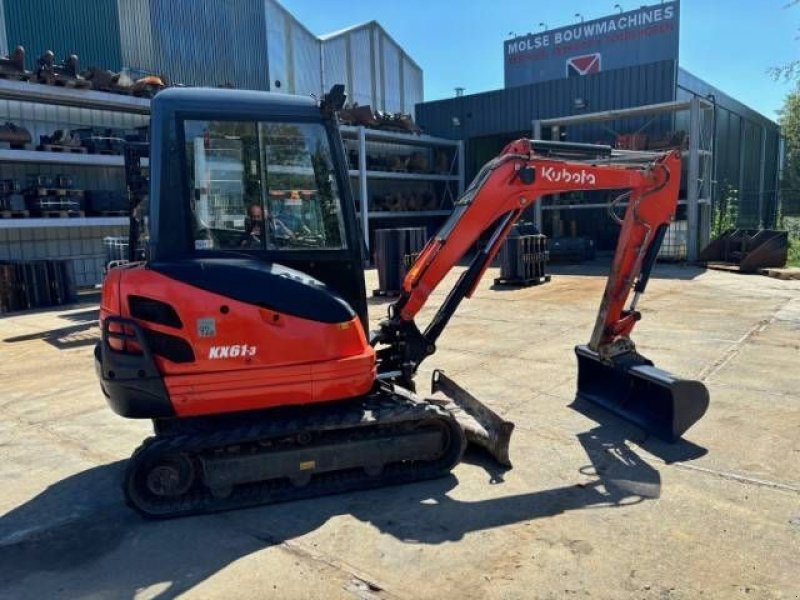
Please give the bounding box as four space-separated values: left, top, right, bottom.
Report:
575 346 708 442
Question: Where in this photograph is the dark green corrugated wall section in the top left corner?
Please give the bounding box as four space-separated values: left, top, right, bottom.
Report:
0 0 122 70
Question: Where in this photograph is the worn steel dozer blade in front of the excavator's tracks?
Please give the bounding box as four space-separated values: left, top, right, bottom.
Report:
431 369 514 467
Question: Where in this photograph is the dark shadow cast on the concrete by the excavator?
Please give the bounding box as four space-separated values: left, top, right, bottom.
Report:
0 424 702 598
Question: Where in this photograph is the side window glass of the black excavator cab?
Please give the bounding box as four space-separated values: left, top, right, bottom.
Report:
184 121 346 251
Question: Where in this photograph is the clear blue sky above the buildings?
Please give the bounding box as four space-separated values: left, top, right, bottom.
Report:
280 0 800 119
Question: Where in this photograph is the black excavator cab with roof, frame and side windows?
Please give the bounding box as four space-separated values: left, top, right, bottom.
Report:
146 88 367 328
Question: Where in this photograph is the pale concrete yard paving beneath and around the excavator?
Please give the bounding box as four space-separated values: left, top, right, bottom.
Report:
0 265 800 600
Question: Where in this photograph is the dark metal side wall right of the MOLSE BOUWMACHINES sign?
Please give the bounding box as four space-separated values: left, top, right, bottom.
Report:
677 69 780 227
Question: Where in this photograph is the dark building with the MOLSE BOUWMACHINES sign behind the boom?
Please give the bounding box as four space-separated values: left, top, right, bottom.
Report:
416 2 780 259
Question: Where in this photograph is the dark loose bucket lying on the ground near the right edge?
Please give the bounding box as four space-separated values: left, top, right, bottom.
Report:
699 229 789 273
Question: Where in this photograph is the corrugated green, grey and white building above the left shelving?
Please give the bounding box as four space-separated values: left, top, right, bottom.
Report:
0 0 423 113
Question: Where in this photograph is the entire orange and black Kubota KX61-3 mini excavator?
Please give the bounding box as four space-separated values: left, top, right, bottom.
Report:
95 86 708 517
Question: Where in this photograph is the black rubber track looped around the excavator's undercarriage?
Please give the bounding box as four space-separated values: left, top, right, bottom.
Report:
123 391 466 519
